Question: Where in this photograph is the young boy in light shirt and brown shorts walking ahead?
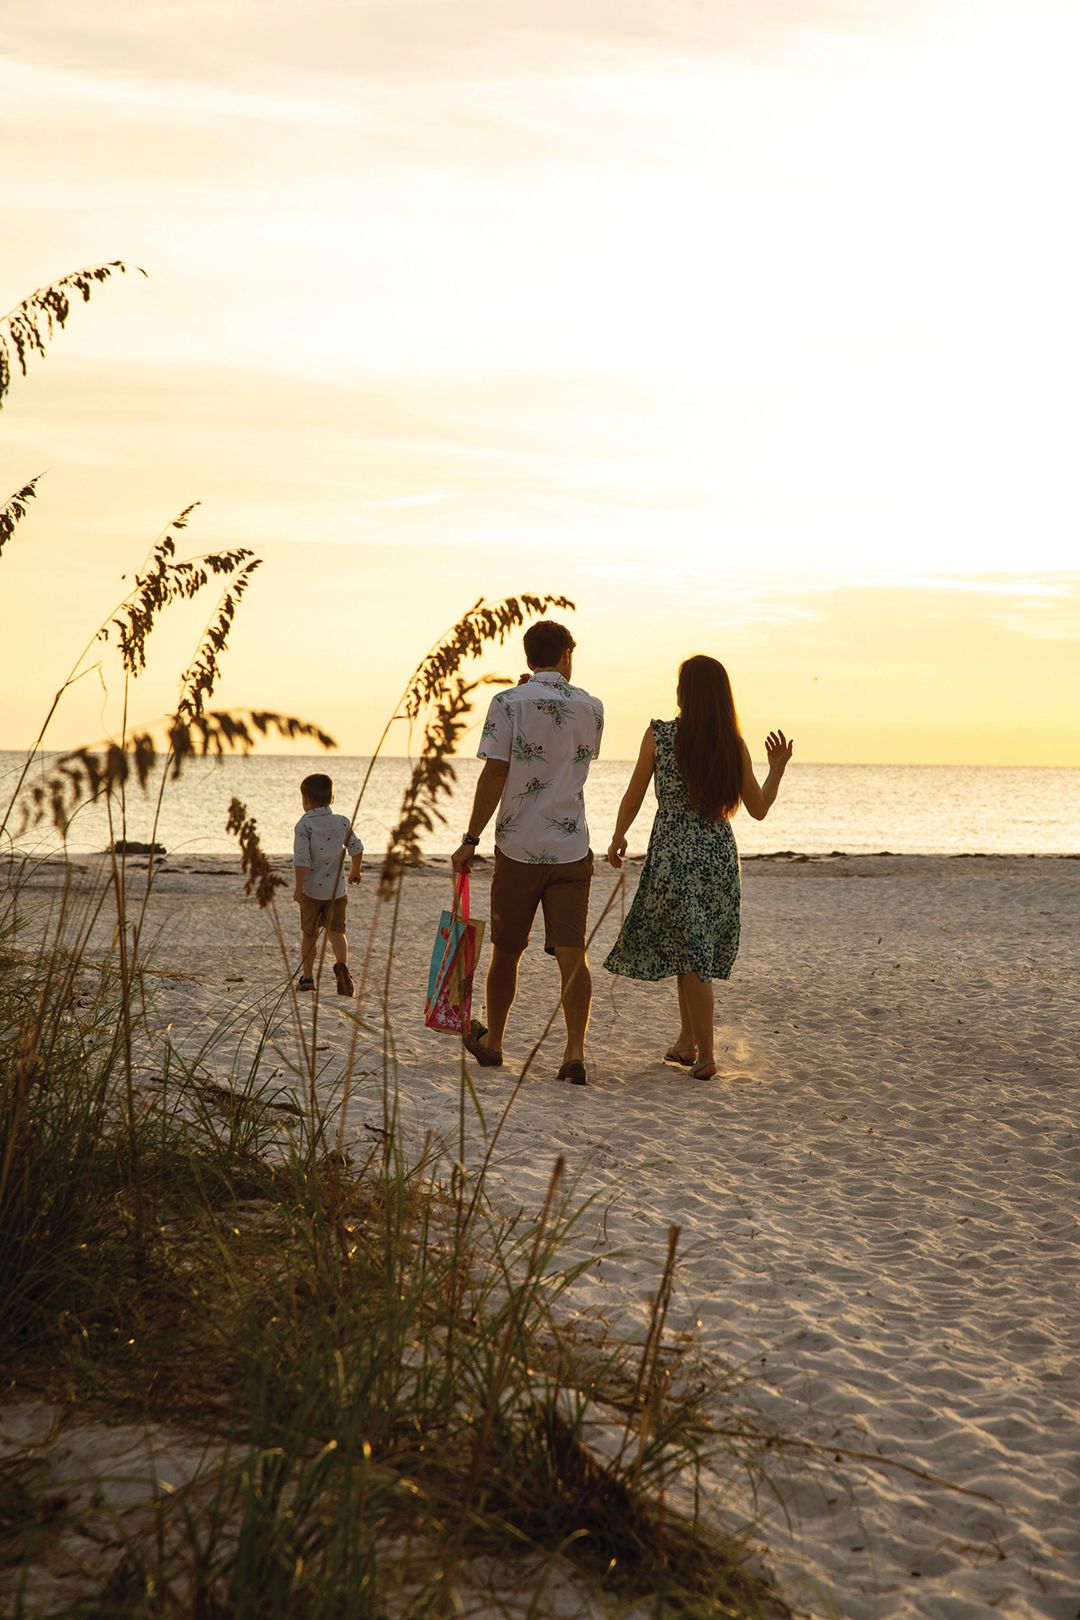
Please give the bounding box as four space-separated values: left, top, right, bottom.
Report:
293 773 364 996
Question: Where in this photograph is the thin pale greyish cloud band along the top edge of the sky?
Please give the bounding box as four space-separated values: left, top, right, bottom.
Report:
5 0 932 91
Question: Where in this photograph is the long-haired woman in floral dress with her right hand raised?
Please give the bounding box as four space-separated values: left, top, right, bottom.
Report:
604 653 792 1081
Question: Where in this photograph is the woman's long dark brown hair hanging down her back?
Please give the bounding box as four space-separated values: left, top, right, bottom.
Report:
675 653 743 821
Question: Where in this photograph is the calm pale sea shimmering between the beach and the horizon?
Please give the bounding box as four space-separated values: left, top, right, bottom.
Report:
0 752 1080 857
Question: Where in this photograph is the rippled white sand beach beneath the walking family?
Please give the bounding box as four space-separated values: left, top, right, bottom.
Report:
4 857 1080 1620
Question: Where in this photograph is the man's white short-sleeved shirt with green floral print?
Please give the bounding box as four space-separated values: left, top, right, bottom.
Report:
476 669 604 867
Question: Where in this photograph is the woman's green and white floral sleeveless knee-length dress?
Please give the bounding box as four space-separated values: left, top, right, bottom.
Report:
604 719 742 982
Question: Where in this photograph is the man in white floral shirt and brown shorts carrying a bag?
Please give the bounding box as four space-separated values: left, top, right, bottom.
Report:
453 619 604 1085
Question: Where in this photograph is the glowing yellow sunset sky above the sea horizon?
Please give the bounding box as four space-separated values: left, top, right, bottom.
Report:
0 0 1080 765
